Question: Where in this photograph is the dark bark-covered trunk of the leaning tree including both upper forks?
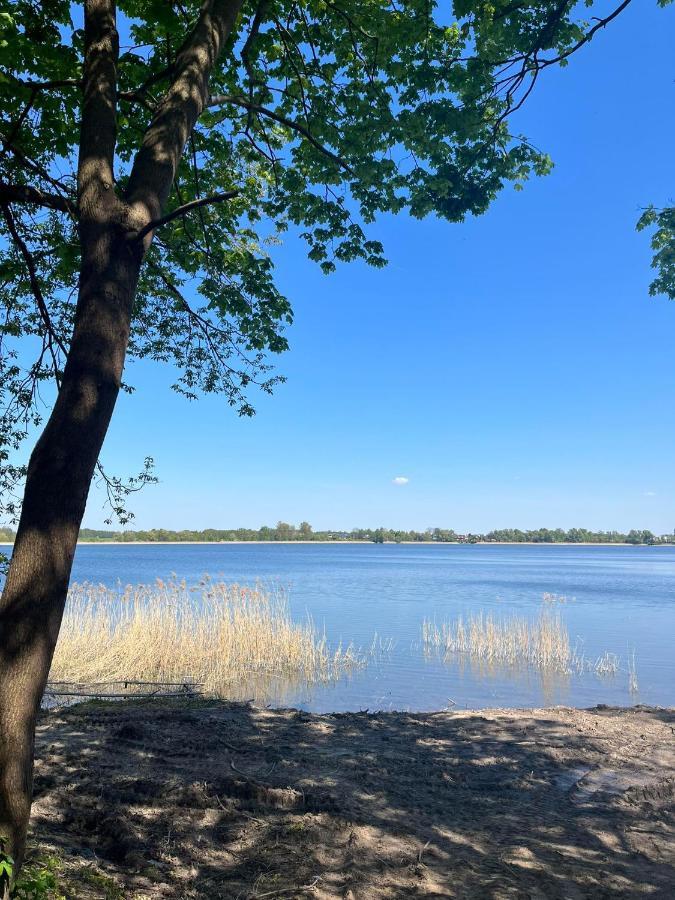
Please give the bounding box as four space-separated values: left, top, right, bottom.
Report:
0 0 241 884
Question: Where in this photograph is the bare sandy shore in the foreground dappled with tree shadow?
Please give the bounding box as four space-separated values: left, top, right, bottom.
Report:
33 701 675 900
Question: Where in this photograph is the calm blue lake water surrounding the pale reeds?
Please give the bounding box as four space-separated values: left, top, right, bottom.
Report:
15 544 675 711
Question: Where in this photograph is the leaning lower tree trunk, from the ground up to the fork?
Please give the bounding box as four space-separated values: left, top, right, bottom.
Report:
0 216 142 880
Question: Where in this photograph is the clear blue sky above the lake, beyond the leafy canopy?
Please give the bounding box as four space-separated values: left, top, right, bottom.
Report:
84 0 675 532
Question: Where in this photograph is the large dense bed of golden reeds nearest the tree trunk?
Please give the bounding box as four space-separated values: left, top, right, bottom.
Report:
50 580 364 697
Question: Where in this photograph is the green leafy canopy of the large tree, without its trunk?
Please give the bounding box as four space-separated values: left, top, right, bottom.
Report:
0 0 656 512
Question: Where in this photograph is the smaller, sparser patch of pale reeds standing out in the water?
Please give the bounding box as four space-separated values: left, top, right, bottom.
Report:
422 609 573 673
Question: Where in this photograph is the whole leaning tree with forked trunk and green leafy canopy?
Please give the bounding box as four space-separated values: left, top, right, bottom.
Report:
0 0 644 884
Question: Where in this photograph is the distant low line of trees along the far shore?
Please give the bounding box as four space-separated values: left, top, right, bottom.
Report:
0 522 675 544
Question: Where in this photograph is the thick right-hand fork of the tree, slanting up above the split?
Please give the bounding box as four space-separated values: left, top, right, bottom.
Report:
127 0 242 236
